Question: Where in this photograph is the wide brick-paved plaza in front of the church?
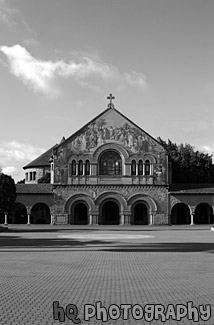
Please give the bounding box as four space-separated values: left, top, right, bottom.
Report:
0 225 214 325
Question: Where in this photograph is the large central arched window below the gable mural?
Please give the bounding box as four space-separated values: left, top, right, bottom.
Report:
99 151 122 176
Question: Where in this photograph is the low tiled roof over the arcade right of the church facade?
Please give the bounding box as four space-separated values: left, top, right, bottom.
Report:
169 183 214 194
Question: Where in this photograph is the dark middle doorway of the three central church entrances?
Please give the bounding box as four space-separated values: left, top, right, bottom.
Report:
101 201 119 225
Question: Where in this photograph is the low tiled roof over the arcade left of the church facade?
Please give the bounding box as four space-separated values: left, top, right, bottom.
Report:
16 183 53 194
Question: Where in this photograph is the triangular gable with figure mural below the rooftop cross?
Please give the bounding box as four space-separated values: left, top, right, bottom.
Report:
54 107 164 154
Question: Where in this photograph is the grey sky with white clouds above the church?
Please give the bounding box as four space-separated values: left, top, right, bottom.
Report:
0 0 214 181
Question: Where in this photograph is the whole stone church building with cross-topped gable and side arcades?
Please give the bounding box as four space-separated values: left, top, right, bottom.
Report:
10 94 214 226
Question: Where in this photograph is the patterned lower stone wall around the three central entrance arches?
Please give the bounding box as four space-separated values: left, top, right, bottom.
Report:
53 185 168 224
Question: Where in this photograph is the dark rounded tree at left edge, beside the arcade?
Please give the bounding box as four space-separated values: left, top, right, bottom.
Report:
0 173 16 214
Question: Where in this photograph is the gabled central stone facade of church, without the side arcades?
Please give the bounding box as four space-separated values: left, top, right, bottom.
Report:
48 105 168 225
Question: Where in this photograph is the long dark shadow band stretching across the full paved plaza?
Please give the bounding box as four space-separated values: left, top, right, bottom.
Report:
0 235 214 253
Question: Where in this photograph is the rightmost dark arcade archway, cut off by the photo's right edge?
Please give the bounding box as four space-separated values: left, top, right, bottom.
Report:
194 203 213 225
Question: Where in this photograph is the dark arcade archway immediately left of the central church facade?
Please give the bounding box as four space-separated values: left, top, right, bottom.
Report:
30 203 51 224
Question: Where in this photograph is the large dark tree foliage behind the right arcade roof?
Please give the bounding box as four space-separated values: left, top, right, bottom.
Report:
158 138 214 183
